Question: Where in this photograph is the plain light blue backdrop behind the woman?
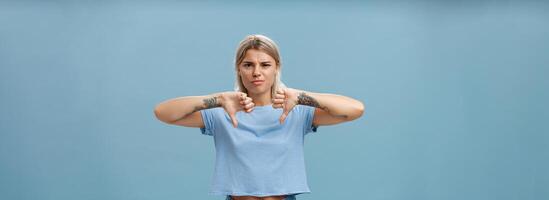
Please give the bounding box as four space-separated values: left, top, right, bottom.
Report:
0 1 549 200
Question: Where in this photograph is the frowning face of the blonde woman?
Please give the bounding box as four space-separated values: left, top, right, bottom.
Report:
238 49 278 95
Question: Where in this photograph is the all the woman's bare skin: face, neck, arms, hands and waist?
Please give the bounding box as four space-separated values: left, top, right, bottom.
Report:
154 49 364 200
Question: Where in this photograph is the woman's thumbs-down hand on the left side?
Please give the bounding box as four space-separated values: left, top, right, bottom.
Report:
221 92 255 128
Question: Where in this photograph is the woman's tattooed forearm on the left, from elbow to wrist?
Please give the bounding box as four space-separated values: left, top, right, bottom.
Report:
154 93 222 122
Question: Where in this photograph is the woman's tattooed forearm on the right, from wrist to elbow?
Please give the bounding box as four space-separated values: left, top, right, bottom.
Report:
297 90 364 120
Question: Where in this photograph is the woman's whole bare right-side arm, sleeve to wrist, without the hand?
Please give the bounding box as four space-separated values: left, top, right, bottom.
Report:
297 90 364 126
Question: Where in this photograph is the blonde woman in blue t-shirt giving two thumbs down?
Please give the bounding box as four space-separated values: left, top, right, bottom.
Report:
154 35 364 200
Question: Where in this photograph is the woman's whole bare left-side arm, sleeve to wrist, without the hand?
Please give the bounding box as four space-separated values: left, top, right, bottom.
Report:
154 93 223 127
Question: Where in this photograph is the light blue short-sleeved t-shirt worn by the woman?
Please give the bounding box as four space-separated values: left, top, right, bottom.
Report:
200 105 317 196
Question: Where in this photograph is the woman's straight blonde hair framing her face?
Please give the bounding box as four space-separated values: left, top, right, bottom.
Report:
234 34 286 99
